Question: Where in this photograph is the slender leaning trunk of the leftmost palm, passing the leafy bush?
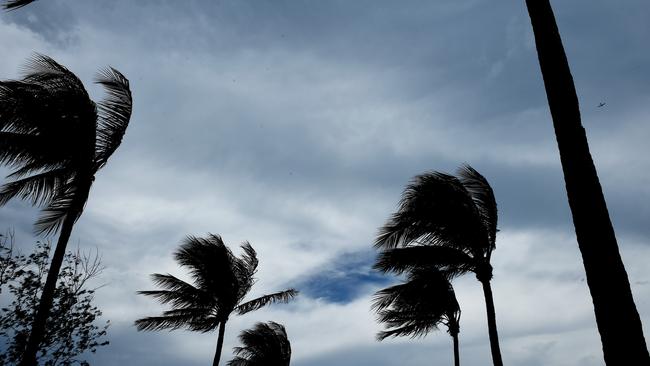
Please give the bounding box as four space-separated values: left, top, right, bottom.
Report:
20 214 78 366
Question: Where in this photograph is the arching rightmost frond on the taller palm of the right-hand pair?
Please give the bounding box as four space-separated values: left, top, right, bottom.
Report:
458 164 499 250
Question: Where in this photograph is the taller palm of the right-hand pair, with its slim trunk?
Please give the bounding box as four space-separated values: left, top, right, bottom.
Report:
375 165 503 366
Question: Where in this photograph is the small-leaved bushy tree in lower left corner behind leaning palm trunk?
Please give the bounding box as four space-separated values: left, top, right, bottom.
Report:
0 234 109 366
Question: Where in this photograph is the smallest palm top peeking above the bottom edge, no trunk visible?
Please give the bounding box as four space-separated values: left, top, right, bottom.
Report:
227 322 291 366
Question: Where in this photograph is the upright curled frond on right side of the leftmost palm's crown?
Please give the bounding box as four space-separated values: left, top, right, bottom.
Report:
95 67 133 169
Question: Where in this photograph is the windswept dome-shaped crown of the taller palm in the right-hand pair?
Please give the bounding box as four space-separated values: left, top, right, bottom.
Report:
375 165 498 270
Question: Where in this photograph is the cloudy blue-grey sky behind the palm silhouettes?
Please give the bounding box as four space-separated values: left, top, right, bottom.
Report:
0 0 650 366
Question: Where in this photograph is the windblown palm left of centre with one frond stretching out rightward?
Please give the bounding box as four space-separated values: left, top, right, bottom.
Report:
135 234 298 366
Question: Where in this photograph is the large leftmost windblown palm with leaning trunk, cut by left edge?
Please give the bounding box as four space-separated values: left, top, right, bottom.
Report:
0 55 132 366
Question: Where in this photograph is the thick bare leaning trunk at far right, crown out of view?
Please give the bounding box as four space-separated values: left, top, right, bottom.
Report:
526 0 650 365
